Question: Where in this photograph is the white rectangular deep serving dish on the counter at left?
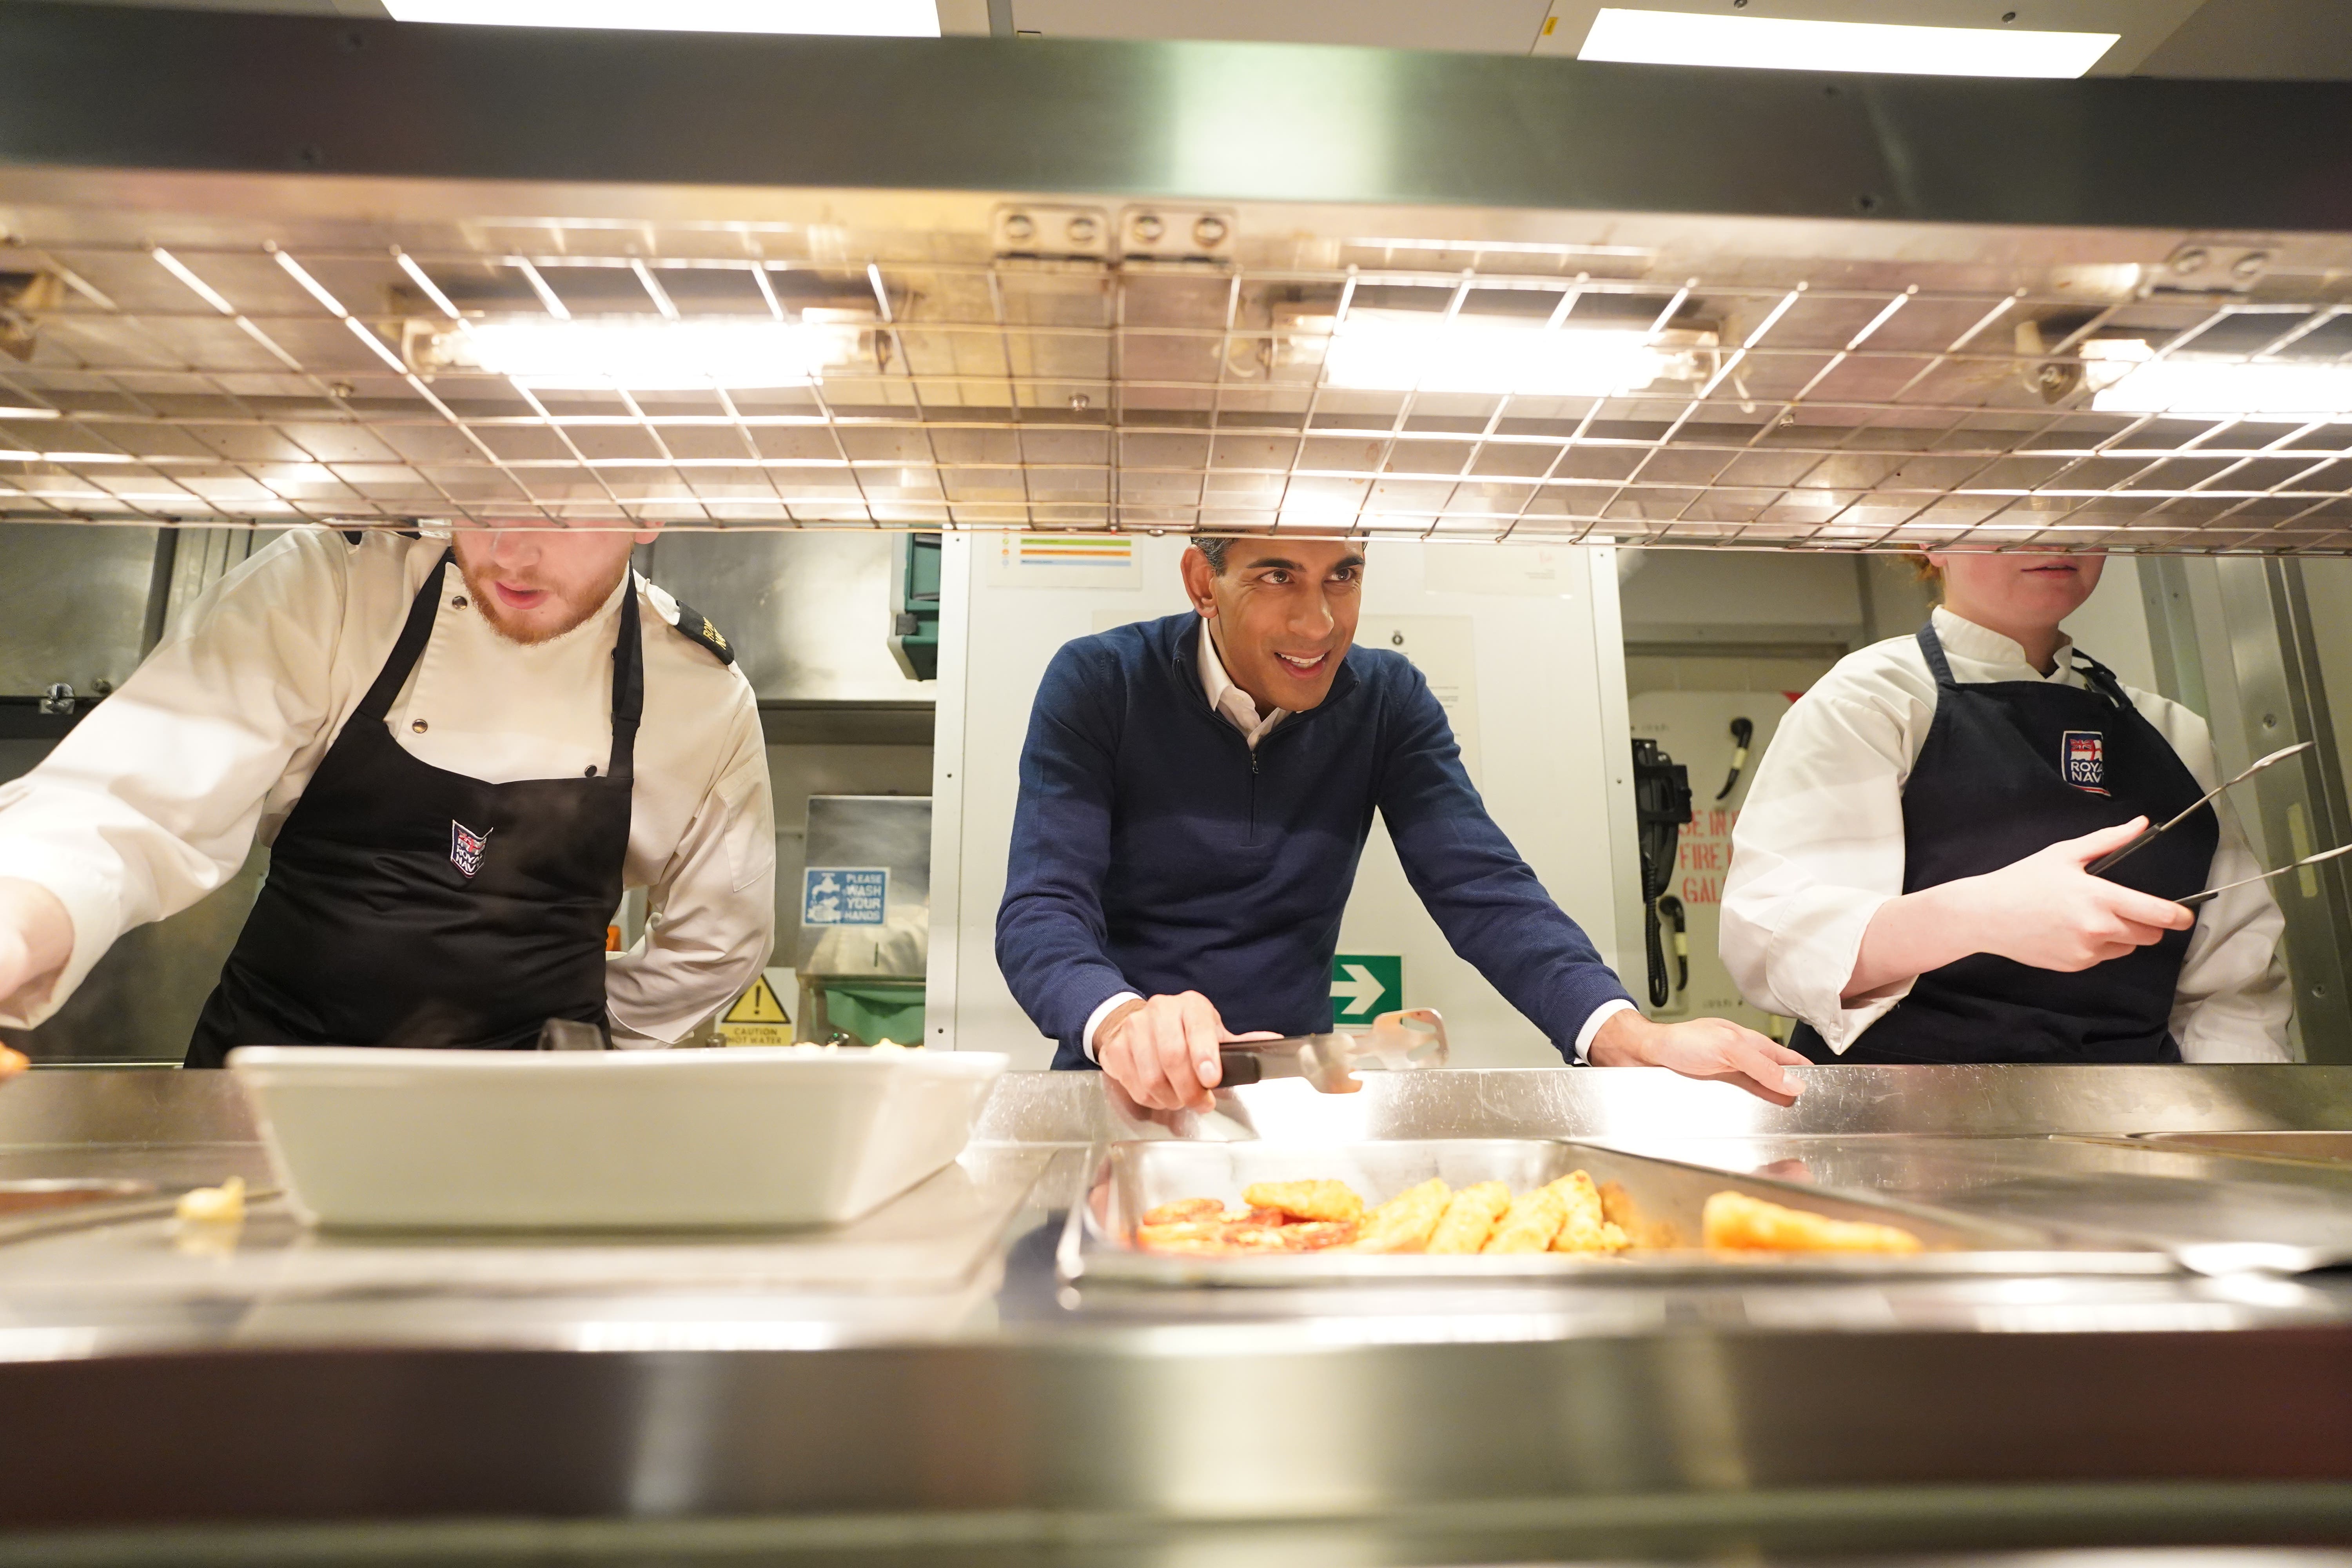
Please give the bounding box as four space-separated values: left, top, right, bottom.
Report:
228 1046 1007 1229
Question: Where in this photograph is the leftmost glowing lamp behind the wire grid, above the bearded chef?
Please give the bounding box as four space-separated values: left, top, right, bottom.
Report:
437 318 858 392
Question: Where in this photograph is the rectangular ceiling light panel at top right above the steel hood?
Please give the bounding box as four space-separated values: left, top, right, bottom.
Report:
1576 7 2122 78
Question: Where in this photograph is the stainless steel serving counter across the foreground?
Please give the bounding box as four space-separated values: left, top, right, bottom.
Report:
14 1067 2352 1563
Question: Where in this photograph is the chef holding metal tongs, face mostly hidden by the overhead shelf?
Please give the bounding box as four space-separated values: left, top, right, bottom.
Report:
1722 552 2288 1063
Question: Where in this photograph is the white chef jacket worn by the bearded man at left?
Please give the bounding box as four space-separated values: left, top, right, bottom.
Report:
0 529 776 1046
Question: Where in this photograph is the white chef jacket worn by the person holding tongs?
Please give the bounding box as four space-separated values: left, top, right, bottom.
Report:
1722 609 2293 1063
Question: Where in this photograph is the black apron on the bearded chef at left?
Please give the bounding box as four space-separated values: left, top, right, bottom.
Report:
188 555 644 1067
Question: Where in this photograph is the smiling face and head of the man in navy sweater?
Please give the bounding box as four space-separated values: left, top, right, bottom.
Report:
1183 538 1364 712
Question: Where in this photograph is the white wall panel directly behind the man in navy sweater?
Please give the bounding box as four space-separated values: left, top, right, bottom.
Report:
927 534 1642 1067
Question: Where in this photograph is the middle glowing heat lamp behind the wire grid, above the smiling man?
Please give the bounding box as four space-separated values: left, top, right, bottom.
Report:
1298 310 1691 397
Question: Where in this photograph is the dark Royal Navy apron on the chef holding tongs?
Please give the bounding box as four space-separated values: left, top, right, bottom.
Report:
1790 623 2220 1063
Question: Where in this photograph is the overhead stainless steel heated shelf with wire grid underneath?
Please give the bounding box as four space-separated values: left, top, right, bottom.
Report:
0 0 2352 552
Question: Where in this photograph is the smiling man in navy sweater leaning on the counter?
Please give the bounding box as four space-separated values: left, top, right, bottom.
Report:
997 538 1806 1107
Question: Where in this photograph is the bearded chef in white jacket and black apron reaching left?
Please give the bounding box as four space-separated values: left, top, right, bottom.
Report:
0 524 776 1067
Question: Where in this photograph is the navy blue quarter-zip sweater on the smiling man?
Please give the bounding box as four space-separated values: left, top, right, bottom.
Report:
997 613 1630 1067
